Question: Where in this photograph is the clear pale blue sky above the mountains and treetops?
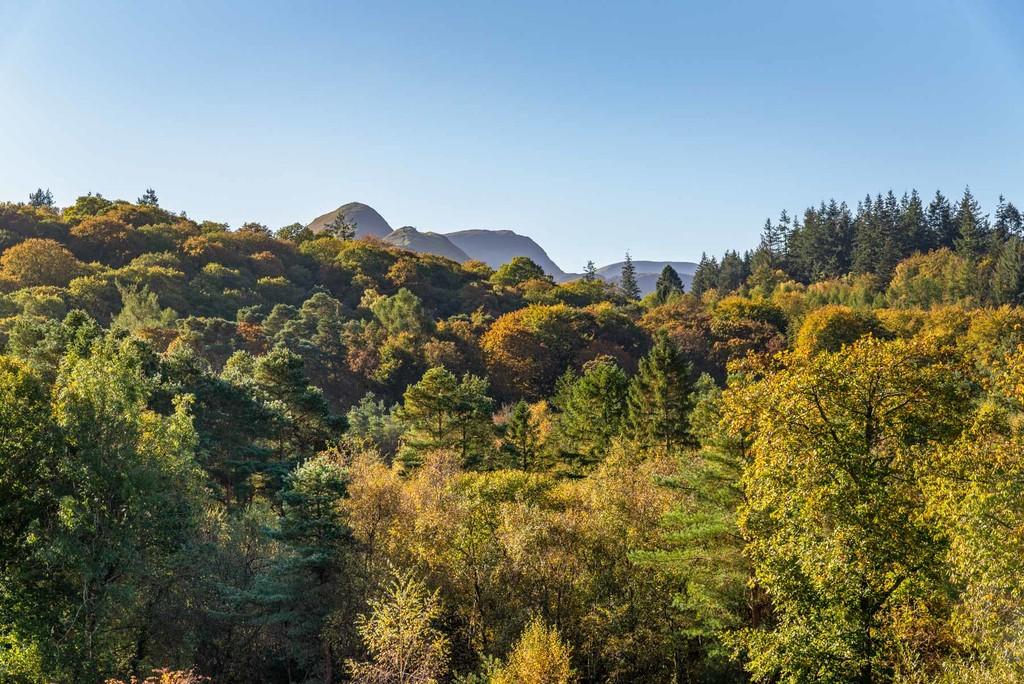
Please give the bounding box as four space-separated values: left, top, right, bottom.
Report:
0 0 1024 270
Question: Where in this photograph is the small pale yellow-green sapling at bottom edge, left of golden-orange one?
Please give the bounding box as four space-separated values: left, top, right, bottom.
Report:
347 573 449 684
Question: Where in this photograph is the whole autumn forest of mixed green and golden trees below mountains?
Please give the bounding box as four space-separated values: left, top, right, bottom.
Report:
0 189 1024 684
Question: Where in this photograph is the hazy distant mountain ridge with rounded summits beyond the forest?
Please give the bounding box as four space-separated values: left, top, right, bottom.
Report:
307 202 697 294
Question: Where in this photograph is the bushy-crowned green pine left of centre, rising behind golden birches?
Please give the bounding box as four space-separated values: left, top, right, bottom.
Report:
398 368 494 465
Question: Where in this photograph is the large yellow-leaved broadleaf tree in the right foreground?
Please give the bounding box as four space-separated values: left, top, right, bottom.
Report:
725 338 971 682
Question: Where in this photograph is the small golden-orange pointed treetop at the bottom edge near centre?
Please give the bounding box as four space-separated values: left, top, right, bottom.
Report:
492 617 577 684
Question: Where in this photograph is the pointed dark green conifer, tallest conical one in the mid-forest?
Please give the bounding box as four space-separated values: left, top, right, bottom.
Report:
626 335 693 450
